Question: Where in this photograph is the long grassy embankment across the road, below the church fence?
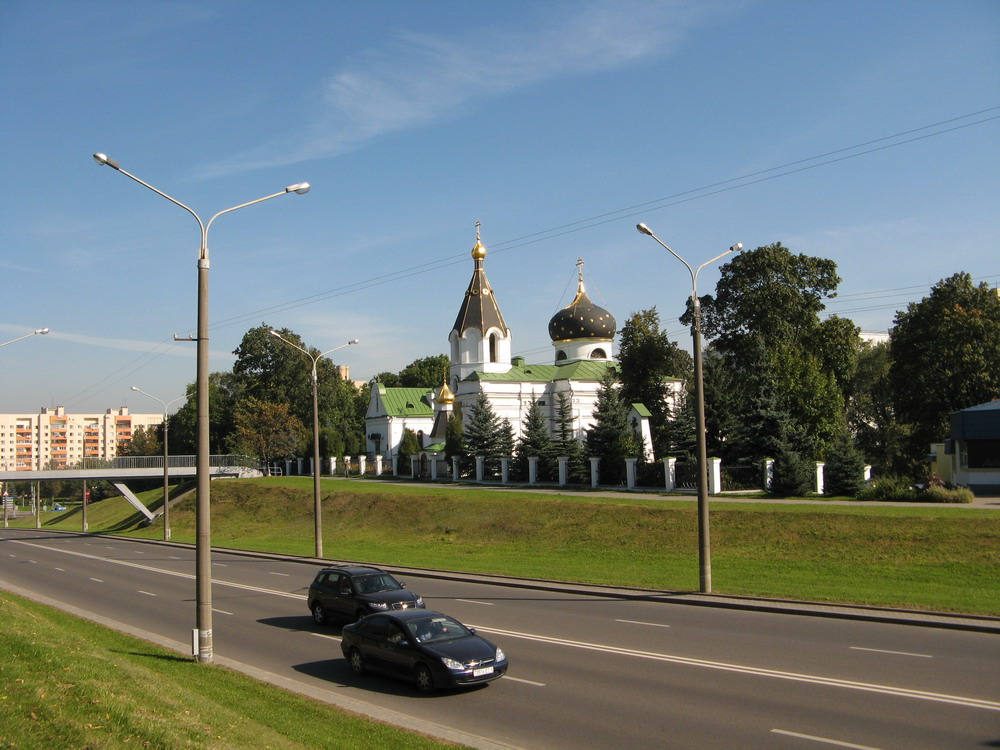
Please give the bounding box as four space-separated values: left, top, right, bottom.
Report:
18 477 1000 615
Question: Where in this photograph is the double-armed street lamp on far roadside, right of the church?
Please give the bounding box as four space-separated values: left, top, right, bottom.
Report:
635 224 743 594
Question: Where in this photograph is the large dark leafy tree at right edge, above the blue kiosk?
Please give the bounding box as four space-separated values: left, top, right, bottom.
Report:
889 272 1000 476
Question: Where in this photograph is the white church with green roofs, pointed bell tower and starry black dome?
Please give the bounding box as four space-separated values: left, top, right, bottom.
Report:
365 222 682 468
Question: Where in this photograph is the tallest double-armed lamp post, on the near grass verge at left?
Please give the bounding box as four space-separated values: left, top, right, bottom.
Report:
94 153 309 663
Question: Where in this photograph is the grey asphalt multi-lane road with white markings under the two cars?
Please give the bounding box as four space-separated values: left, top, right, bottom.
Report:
0 529 1000 750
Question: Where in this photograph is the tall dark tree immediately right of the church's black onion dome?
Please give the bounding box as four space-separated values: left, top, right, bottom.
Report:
618 307 693 456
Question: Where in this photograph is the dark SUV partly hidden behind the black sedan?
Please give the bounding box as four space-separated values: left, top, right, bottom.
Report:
309 565 424 625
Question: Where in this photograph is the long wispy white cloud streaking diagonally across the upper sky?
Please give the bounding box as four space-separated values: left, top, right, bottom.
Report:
201 0 720 177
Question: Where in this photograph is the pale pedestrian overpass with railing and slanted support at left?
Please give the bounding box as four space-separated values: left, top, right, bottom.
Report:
0 456 264 521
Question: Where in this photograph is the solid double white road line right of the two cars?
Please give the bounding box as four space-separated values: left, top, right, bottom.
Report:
475 625 1000 711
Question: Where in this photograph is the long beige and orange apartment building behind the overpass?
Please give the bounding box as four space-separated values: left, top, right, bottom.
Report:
0 406 163 471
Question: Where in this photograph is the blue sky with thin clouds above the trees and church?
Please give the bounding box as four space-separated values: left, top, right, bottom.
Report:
0 0 1000 413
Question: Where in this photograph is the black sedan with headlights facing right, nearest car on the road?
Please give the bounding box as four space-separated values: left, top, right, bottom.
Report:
340 609 507 693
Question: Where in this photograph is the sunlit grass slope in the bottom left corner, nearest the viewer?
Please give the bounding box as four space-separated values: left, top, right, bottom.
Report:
0 592 454 750
